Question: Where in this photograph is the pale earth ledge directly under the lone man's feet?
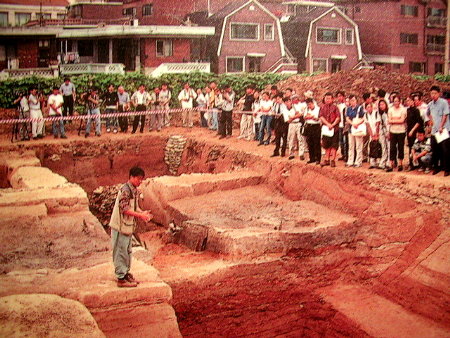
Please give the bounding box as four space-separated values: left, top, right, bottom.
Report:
0 259 181 337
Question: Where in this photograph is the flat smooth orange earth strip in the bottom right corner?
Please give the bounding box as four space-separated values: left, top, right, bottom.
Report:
320 284 450 338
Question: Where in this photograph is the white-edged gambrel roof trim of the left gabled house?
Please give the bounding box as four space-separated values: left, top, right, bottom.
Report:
210 0 286 56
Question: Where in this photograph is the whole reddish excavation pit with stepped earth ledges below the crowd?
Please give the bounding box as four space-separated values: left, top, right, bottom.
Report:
0 129 450 337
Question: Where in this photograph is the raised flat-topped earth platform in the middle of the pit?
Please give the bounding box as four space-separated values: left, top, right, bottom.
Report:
169 185 355 255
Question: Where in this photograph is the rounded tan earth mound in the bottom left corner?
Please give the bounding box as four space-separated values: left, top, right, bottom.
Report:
0 294 105 338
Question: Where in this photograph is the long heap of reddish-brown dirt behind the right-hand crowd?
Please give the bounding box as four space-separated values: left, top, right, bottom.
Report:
278 69 450 100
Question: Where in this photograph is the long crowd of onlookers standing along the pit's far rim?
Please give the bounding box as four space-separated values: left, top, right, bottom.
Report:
15 78 450 176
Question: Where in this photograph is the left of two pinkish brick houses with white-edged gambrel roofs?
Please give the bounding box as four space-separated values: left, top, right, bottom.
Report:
199 0 286 73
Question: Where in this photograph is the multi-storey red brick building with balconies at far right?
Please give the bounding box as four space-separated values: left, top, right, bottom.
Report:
340 0 447 75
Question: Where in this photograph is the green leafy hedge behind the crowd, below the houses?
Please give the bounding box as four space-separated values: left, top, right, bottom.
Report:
0 72 296 108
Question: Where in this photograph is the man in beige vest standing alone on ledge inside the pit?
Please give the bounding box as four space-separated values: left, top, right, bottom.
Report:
109 167 153 287
